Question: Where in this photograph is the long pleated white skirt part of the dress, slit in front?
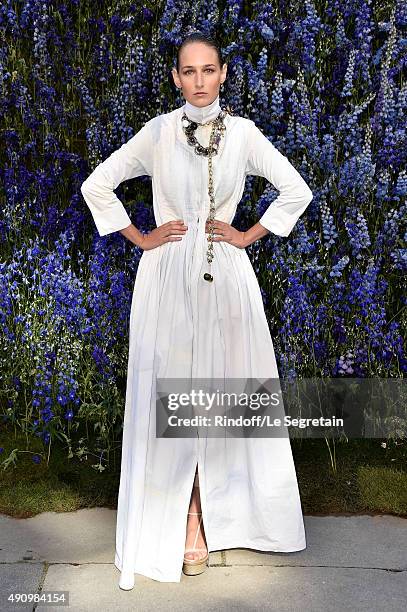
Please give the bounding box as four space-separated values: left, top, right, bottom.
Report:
115 211 306 588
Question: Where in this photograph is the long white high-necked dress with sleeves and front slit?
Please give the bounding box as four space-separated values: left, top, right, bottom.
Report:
81 97 312 589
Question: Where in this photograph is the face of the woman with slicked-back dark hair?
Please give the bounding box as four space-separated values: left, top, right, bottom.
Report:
172 42 227 106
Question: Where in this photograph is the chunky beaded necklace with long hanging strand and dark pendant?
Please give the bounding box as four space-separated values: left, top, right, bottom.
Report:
181 108 231 282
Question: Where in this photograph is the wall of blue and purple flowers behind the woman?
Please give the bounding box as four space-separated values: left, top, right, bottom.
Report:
0 0 407 470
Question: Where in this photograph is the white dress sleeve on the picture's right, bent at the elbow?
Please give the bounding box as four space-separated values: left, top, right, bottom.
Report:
246 120 313 236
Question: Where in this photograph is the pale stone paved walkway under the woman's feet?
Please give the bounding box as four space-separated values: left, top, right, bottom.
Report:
0 508 407 612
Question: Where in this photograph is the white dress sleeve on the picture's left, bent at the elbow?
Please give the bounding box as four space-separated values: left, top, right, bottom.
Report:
81 120 153 236
